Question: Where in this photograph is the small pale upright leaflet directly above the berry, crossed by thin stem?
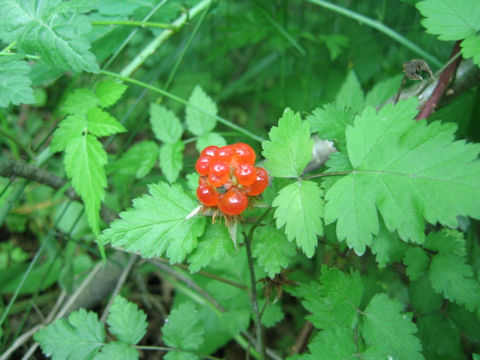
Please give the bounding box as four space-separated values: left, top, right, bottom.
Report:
185 85 218 136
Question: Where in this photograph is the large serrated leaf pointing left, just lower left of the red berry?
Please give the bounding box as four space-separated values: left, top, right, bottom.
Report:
100 182 205 263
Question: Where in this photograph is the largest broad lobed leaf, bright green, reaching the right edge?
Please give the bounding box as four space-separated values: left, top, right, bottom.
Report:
325 100 480 254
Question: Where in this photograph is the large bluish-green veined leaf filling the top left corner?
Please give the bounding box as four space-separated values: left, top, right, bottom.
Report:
0 0 99 72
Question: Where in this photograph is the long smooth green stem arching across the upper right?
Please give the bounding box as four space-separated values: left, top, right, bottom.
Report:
308 0 443 68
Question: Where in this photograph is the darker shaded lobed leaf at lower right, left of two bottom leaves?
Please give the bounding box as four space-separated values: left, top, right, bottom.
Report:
299 267 363 330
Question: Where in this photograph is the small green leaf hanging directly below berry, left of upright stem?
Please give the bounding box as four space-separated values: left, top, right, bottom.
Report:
188 222 234 272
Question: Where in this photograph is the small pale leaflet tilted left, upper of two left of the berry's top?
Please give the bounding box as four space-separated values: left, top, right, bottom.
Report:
150 103 183 143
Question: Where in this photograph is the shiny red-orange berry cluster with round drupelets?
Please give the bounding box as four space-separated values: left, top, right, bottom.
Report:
195 143 268 215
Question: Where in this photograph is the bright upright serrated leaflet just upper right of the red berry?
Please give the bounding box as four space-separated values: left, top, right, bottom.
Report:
262 108 313 177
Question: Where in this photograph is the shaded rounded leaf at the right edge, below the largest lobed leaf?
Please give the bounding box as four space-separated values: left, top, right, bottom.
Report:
428 254 480 311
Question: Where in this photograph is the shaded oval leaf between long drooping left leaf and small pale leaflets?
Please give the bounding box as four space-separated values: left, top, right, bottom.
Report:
107 141 159 179
